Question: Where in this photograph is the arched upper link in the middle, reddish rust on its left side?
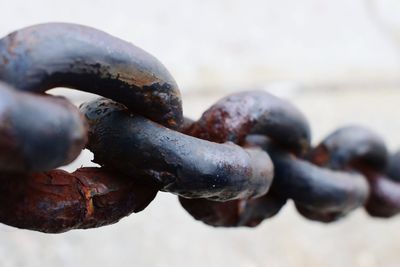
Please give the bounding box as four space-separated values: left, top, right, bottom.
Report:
186 91 311 155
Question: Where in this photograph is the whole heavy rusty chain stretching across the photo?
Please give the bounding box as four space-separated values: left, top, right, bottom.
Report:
0 23 400 233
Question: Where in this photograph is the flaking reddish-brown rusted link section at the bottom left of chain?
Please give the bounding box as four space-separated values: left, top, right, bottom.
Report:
0 168 158 233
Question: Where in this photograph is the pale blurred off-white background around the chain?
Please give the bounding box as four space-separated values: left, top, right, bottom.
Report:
0 0 400 267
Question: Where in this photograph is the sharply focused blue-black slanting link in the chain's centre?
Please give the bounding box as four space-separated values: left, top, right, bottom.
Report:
81 99 273 200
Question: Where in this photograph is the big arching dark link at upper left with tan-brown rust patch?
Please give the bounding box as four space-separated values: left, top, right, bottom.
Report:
0 23 182 128
